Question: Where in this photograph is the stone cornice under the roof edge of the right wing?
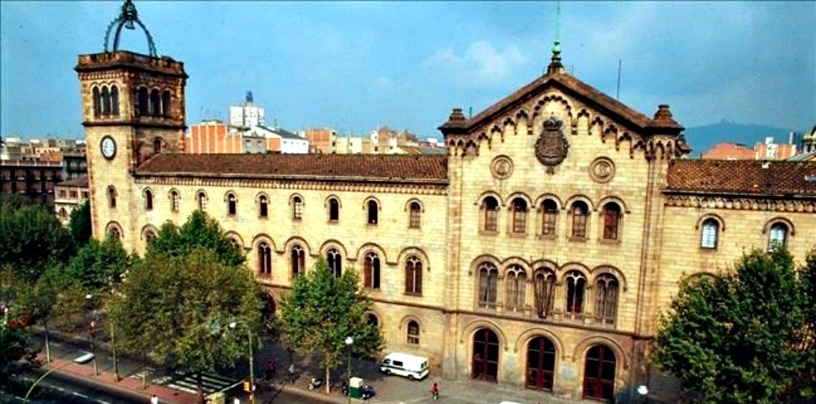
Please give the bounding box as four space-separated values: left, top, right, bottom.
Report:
664 193 816 213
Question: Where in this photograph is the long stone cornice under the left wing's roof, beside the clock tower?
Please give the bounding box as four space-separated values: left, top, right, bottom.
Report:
134 175 448 196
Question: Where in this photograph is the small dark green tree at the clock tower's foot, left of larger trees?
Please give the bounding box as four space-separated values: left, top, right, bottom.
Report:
63 237 132 290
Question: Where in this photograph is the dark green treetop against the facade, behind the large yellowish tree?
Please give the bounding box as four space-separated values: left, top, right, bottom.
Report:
146 210 245 266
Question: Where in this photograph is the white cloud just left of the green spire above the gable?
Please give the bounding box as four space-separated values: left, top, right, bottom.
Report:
422 41 526 86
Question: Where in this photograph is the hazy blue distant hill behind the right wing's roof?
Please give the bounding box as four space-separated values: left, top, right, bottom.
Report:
683 122 802 158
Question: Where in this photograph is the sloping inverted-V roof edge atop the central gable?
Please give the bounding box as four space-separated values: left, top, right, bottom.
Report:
440 73 684 133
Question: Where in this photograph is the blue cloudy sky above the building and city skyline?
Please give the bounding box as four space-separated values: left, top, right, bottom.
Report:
0 0 816 138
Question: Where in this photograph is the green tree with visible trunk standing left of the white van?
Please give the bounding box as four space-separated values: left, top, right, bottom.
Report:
279 259 383 393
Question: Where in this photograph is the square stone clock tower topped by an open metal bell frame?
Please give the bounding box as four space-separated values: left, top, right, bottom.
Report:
74 0 187 245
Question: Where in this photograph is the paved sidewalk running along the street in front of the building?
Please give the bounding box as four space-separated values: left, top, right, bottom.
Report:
23 334 588 404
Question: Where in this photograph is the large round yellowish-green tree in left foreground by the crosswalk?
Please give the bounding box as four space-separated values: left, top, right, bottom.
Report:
108 248 263 398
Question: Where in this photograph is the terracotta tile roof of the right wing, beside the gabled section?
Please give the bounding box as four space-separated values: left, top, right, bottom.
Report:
666 160 816 196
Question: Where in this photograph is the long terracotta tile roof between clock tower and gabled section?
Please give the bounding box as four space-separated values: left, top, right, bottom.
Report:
136 154 448 183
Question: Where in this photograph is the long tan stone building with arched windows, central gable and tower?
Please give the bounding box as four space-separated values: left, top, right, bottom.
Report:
77 2 816 400
